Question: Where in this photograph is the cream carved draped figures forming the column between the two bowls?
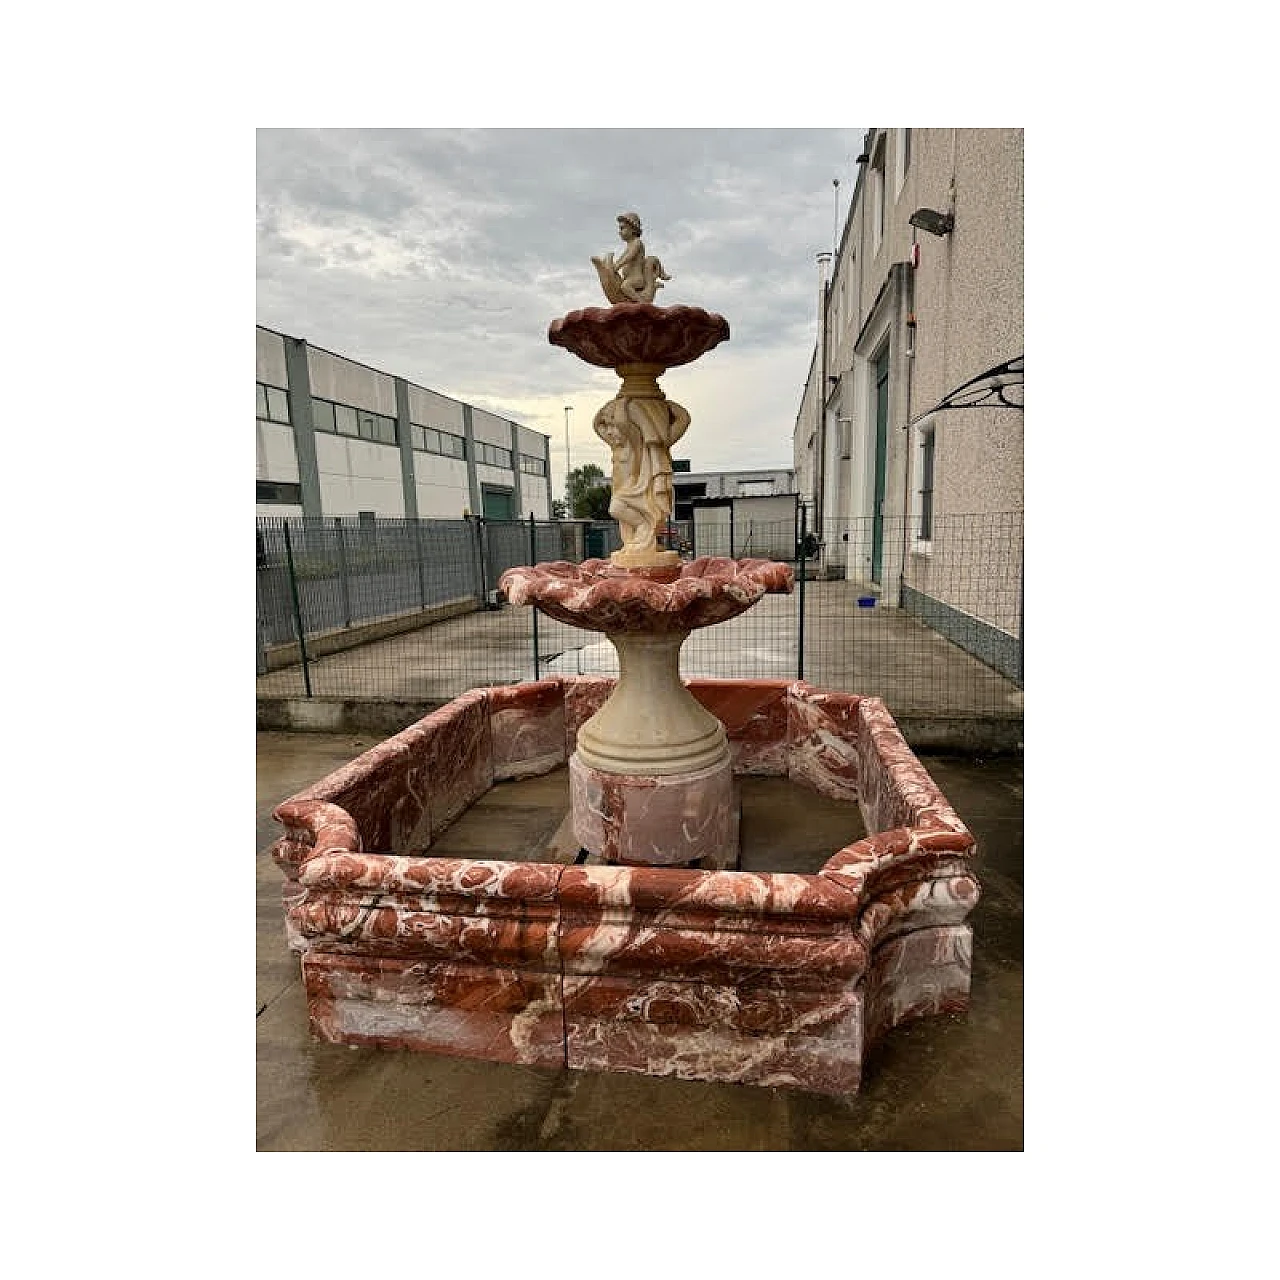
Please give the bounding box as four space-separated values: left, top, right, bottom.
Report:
591 396 689 561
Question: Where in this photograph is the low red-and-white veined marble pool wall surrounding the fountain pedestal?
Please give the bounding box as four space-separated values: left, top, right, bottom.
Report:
264 677 978 1093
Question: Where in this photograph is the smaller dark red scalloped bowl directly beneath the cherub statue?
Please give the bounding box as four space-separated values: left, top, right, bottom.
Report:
547 302 728 369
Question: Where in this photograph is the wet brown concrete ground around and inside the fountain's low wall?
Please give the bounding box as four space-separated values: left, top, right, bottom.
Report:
256 732 1023 1151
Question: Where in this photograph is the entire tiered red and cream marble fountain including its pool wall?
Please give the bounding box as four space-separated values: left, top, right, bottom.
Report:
264 214 978 1094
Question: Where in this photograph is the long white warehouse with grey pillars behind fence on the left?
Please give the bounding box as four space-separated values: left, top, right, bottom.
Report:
256 325 552 520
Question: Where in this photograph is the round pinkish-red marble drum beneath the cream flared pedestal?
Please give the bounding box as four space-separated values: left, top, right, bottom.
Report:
568 751 740 870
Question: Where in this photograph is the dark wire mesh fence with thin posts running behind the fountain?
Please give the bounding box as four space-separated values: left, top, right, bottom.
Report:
257 512 1023 717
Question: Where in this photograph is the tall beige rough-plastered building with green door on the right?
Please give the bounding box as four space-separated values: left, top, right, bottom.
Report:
794 129 1024 627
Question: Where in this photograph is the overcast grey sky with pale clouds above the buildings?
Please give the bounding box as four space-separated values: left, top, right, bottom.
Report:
257 128 865 495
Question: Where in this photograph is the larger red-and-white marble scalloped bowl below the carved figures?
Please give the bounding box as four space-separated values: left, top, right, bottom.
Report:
498 556 795 635
